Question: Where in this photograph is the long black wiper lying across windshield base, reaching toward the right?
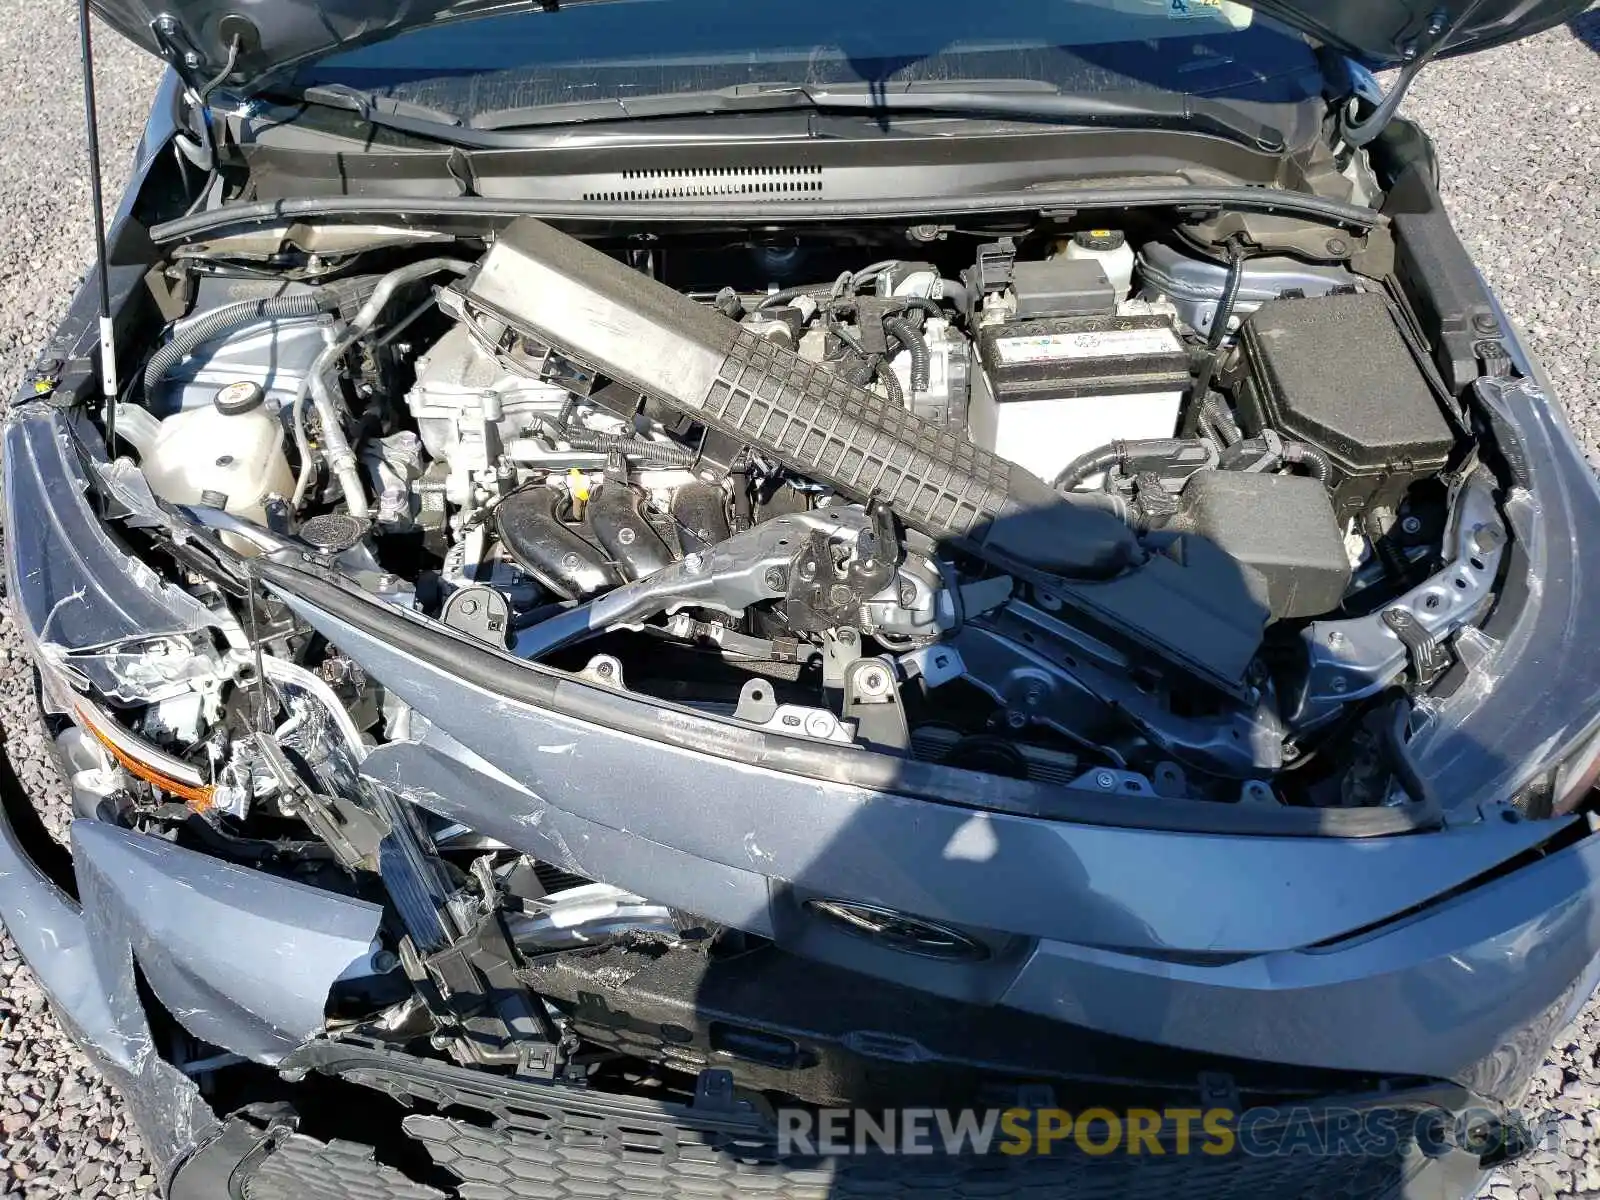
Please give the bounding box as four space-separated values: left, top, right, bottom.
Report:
461 80 1285 152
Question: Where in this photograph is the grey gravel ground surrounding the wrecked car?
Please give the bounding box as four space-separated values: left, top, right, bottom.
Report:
0 0 1600 1200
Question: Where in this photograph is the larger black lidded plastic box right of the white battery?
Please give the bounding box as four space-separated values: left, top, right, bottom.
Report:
1237 293 1456 520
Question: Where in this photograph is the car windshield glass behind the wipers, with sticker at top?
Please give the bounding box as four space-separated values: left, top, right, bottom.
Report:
294 0 1322 120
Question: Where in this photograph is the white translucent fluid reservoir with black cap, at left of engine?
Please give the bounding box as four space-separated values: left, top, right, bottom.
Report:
134 382 294 554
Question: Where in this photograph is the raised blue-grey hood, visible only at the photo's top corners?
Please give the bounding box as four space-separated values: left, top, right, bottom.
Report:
91 0 1589 91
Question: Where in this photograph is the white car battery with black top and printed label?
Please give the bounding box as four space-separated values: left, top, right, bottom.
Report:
968 315 1189 482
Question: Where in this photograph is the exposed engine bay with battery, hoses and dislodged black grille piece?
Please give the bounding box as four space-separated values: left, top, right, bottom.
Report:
107 216 1506 818
